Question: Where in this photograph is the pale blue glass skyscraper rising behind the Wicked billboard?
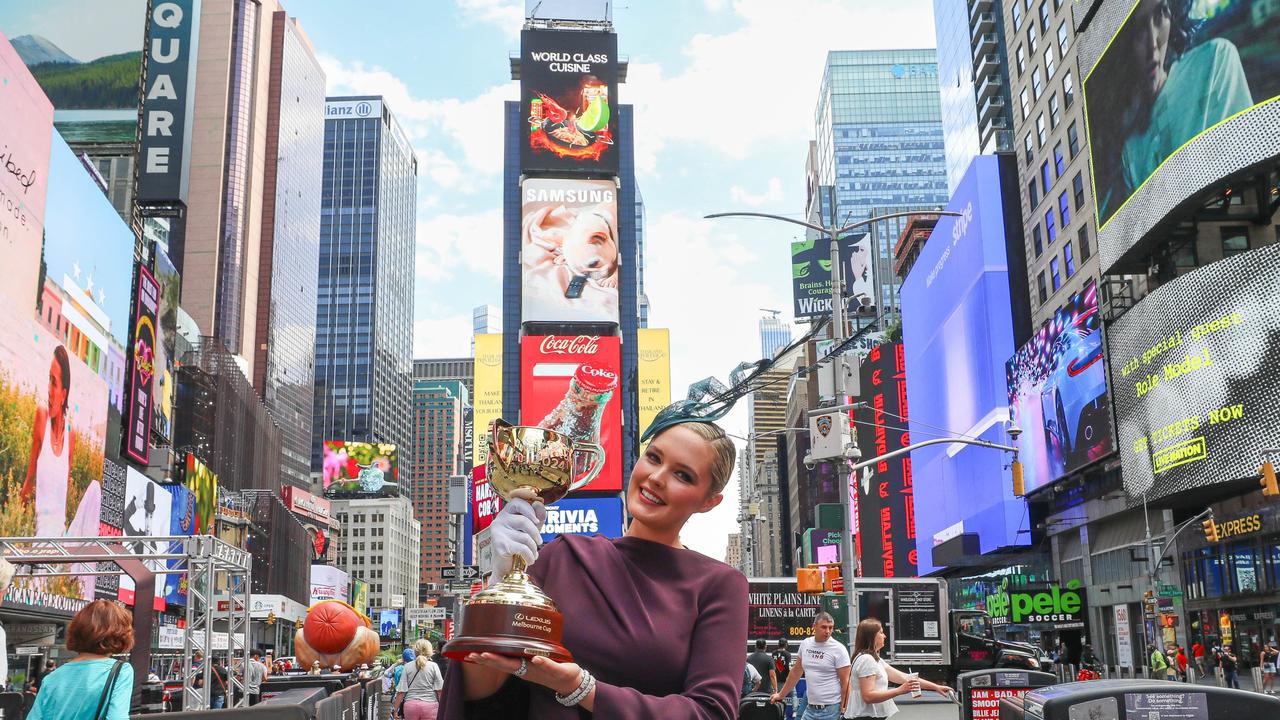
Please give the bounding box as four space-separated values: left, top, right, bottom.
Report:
809 49 947 310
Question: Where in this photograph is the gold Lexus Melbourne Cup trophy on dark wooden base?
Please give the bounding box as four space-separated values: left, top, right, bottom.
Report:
443 419 604 662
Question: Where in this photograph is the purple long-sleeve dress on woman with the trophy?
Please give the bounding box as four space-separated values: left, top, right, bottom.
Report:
440 536 746 720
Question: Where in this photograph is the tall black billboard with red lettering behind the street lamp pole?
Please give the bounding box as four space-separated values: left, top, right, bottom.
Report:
855 342 916 578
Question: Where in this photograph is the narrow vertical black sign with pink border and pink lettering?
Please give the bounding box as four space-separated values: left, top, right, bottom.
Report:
124 265 160 458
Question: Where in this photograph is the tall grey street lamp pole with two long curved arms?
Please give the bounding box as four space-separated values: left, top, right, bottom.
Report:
707 204 960 620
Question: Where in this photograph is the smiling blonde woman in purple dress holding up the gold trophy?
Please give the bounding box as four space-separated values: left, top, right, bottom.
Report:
440 421 746 720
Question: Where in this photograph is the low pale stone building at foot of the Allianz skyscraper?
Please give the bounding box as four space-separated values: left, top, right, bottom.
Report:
333 496 422 612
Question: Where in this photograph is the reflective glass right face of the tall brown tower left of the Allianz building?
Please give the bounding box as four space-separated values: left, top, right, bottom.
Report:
253 10 325 488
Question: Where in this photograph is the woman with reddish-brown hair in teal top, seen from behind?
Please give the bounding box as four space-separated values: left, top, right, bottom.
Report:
27 600 133 720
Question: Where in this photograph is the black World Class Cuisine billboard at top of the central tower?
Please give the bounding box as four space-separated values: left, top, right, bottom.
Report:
520 29 618 176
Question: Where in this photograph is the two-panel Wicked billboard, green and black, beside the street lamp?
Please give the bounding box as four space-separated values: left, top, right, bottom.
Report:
791 233 876 318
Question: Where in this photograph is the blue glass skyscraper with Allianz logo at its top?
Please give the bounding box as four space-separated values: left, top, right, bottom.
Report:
311 96 417 471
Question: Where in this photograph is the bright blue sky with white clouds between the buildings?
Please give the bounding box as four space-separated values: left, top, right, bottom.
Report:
283 0 934 559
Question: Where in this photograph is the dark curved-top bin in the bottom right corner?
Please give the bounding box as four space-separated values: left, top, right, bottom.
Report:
1023 680 1280 720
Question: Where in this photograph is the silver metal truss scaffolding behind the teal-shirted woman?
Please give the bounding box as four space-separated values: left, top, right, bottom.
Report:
0 536 252 710
